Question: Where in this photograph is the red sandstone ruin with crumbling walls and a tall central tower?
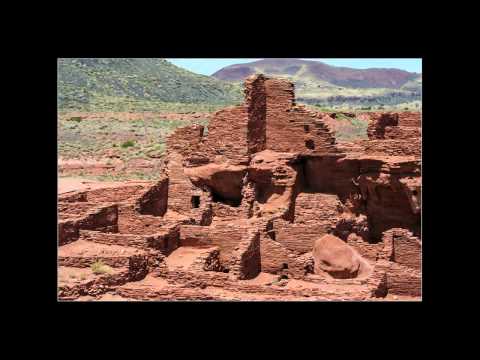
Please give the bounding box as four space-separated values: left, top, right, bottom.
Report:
58 75 422 300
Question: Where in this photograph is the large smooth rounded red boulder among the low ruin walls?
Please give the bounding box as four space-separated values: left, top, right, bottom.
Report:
313 234 370 279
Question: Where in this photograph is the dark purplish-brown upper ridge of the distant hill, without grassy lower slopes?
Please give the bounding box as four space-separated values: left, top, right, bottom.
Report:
212 59 419 89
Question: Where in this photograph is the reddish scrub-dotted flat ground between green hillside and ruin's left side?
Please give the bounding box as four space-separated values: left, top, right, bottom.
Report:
57 112 210 181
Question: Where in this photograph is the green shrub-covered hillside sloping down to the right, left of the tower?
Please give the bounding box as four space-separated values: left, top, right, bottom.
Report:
57 58 243 111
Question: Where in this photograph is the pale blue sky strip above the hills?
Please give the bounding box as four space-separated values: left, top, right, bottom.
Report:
167 59 422 75
